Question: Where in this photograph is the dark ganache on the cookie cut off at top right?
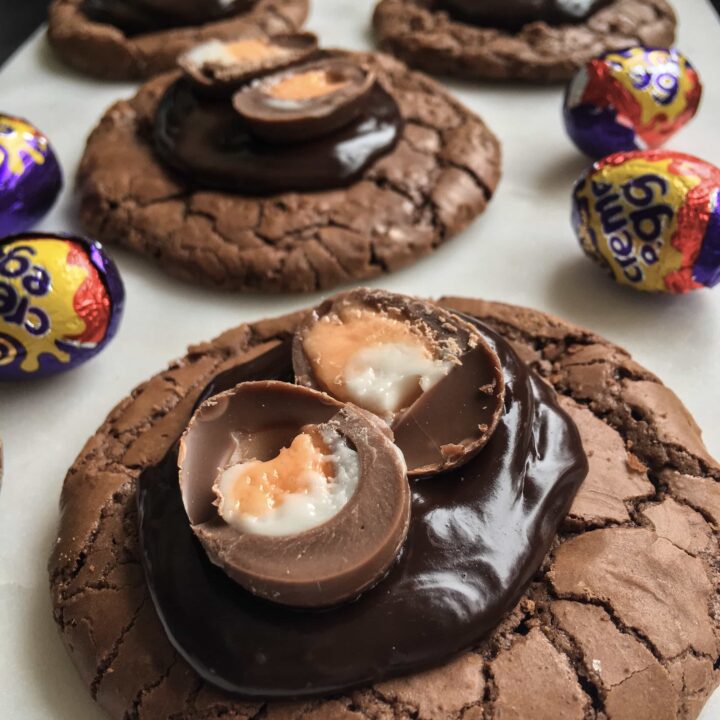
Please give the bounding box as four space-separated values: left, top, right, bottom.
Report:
436 0 611 30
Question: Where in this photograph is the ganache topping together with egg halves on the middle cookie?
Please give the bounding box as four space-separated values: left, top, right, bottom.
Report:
154 46 403 195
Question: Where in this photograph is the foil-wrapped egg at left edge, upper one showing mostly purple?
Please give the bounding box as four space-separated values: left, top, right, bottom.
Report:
0 114 62 236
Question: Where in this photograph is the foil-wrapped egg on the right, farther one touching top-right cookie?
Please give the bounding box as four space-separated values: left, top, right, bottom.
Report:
563 47 702 158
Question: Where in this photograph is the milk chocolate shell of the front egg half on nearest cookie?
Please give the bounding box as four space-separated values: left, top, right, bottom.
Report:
178 381 410 607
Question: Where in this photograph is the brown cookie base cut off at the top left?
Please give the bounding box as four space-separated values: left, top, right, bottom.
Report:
48 0 308 80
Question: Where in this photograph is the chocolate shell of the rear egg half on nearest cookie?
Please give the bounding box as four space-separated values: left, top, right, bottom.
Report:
293 288 505 477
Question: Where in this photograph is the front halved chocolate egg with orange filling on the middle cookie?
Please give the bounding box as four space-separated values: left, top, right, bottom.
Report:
233 58 375 142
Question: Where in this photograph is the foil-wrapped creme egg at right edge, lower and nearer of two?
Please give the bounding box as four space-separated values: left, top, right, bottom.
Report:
572 150 720 293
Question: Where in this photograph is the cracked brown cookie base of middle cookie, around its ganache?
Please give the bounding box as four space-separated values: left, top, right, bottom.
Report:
78 54 500 292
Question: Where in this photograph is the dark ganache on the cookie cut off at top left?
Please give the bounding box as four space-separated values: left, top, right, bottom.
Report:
82 0 256 37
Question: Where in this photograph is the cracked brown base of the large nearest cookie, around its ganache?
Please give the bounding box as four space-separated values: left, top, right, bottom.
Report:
50 298 720 720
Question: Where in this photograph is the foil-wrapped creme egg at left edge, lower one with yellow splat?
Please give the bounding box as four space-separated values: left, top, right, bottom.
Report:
0 233 125 380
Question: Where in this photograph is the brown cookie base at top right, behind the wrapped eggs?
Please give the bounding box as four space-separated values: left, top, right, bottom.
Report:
373 0 675 82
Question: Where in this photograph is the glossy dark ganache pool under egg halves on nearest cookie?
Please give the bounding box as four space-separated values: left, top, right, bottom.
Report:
138 316 587 698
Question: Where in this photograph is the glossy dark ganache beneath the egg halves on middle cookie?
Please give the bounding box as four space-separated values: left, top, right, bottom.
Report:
154 78 403 195
